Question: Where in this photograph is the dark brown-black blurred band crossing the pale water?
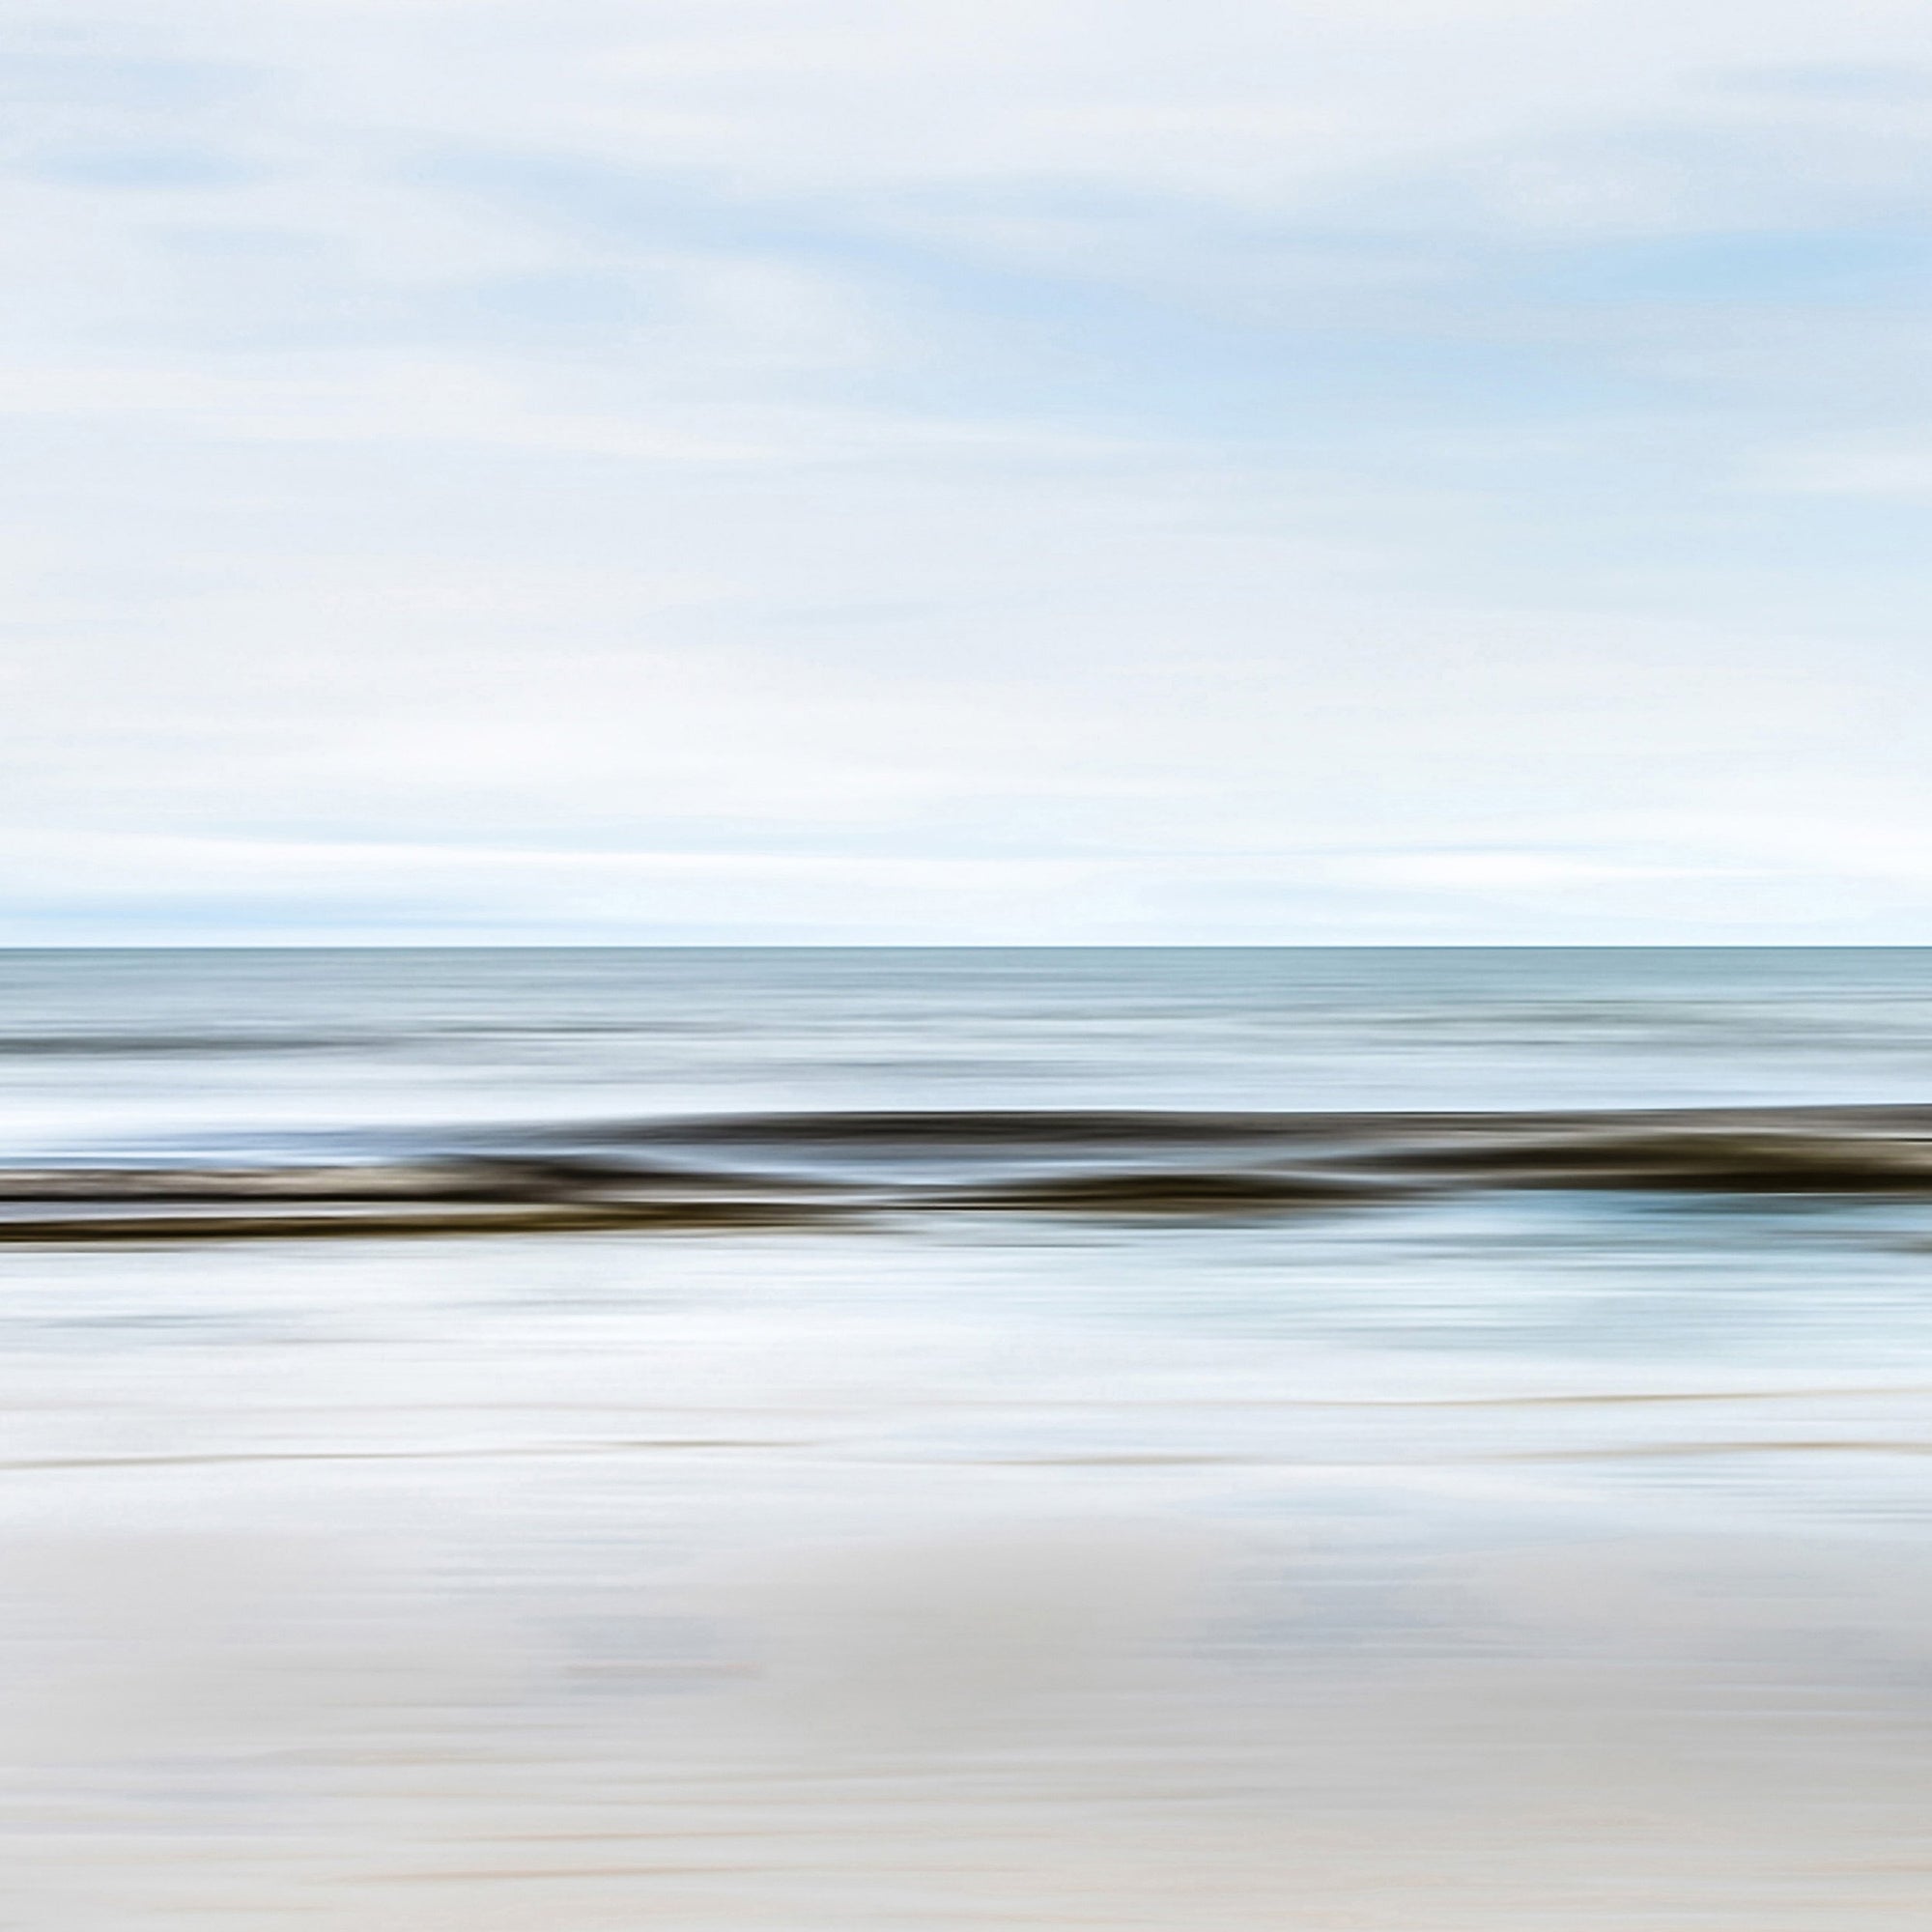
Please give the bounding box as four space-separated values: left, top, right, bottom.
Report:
11 1107 1932 1242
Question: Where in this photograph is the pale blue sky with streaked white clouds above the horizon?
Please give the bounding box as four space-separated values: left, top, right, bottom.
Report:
0 0 1932 945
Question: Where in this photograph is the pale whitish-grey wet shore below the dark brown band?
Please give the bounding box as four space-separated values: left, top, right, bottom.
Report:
0 1202 1932 1932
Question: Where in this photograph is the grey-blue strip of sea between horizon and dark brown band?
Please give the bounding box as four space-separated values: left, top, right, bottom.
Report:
11 949 1932 1157
